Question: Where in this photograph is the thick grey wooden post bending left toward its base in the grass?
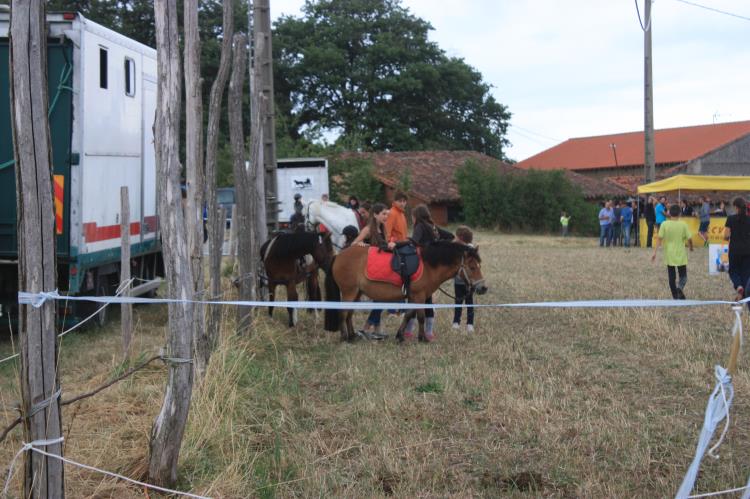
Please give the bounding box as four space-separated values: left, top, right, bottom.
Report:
148 0 194 486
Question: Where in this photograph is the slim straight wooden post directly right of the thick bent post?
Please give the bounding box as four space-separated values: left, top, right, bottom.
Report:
183 0 206 378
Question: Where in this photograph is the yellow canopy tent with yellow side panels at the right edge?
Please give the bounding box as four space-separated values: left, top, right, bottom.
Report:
638 175 750 249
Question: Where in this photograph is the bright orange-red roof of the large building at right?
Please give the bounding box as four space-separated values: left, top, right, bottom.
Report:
516 121 750 170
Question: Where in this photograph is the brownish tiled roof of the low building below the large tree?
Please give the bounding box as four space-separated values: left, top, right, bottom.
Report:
339 151 519 203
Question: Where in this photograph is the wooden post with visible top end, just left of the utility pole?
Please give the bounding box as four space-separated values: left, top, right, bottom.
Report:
229 33 257 334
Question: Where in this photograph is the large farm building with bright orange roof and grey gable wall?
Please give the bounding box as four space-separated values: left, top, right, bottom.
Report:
516 121 750 192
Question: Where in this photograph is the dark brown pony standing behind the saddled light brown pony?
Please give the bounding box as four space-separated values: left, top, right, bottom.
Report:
260 232 333 327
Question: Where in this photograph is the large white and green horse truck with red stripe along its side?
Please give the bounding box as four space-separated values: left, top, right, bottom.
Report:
0 12 163 326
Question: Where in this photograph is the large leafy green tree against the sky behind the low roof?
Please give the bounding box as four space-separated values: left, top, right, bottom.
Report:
273 0 510 158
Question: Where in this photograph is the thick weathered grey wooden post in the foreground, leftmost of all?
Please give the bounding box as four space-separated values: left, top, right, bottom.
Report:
10 0 65 498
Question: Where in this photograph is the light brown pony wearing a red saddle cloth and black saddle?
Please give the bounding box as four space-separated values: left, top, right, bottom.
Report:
325 241 487 341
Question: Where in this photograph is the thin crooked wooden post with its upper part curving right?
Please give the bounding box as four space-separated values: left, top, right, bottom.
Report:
204 0 234 352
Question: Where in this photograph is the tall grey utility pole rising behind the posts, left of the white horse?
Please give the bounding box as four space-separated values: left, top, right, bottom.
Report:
251 0 280 231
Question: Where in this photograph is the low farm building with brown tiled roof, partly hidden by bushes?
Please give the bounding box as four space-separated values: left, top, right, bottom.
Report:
337 151 629 225
